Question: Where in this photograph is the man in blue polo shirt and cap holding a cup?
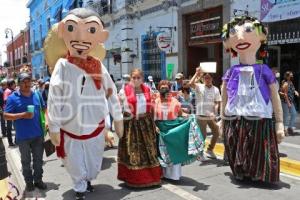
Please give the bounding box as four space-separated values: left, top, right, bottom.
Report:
4 73 47 192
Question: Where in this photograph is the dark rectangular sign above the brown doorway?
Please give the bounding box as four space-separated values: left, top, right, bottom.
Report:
190 16 222 40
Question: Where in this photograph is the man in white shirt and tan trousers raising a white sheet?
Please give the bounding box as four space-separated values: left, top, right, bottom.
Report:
190 68 221 159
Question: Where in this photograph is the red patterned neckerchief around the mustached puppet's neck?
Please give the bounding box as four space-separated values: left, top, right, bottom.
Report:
67 54 102 90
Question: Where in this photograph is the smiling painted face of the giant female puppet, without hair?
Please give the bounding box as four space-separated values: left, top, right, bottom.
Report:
224 22 266 55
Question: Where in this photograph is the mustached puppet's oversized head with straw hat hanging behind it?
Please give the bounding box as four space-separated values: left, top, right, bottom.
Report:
44 8 109 71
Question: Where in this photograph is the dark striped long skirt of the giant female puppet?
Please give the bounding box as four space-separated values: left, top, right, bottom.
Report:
224 117 280 182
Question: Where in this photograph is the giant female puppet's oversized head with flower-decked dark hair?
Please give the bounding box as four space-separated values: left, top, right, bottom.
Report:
222 16 267 60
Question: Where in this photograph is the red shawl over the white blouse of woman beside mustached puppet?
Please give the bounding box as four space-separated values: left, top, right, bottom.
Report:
124 84 151 116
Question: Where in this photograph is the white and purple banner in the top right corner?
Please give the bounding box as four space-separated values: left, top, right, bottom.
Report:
261 0 300 22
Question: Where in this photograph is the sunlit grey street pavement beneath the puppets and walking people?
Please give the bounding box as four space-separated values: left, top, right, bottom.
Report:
4 115 300 200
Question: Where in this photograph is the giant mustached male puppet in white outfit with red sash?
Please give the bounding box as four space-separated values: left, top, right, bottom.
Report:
44 8 123 199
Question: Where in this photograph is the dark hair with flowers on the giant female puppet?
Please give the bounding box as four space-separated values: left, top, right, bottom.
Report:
221 16 267 59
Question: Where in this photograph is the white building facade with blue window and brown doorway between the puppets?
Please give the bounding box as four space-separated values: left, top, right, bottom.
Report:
84 0 230 86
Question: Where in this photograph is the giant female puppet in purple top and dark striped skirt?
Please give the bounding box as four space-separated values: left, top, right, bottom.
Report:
222 16 284 182
